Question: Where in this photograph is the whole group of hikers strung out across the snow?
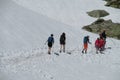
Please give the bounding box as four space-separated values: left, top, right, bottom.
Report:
47 30 106 54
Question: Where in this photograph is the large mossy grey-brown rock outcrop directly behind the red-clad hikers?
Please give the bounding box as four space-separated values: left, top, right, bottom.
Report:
83 19 120 39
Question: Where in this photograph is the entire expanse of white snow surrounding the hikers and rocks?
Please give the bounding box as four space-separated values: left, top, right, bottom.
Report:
0 0 120 80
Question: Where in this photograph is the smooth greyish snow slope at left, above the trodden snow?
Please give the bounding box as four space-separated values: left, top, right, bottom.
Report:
0 0 79 51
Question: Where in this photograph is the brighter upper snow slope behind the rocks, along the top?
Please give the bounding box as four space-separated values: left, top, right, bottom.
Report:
14 0 120 27
